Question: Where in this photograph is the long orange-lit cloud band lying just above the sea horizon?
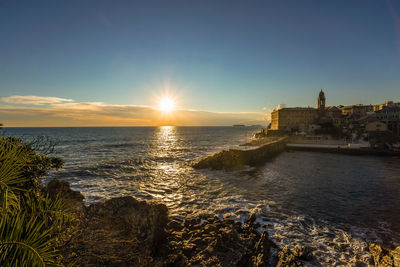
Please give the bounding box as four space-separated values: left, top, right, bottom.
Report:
0 96 266 127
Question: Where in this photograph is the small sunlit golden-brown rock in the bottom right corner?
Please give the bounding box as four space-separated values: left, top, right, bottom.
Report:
368 243 400 267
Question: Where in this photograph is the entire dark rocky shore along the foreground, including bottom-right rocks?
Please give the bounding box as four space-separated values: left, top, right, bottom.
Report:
45 180 400 267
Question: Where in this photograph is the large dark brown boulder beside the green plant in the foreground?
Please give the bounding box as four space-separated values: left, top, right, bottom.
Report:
63 197 168 266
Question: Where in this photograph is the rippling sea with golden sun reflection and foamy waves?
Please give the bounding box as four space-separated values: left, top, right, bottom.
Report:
1 126 400 266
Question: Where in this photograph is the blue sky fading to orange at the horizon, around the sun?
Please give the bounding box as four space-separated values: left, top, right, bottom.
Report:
0 0 400 126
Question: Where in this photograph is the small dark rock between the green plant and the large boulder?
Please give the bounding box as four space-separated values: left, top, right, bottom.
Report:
43 179 84 211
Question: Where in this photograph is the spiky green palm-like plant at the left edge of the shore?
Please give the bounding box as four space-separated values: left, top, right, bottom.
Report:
0 137 73 266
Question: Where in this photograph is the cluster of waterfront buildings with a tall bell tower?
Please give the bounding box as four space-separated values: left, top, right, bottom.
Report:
268 90 400 137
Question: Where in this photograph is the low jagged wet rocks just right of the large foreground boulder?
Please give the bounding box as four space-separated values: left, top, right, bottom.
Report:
165 217 276 266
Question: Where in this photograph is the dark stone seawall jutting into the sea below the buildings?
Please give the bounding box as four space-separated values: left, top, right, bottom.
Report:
193 137 287 170
